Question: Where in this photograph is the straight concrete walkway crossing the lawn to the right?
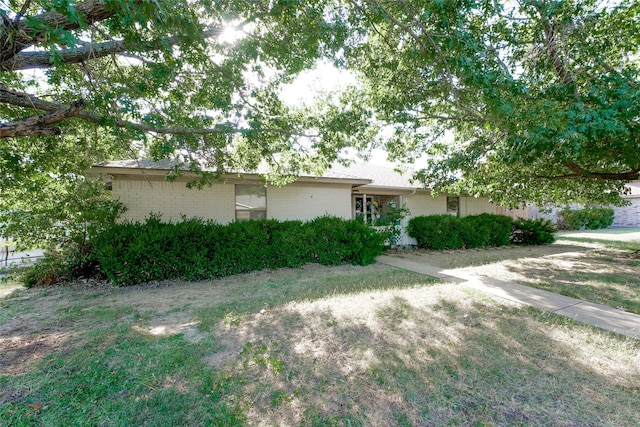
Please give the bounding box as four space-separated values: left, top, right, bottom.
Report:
378 255 640 339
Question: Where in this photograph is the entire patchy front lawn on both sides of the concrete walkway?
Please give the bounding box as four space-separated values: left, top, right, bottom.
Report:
0 240 640 426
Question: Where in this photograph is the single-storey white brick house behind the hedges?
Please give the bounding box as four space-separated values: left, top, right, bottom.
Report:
91 160 498 244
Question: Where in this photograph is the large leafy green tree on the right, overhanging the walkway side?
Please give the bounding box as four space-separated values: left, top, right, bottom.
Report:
349 0 640 205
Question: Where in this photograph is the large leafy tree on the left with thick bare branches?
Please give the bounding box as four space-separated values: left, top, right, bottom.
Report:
0 0 366 246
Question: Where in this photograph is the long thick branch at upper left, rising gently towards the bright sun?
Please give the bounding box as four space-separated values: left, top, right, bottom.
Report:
0 28 223 71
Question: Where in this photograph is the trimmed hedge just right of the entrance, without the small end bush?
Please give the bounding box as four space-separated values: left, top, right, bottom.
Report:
407 214 512 250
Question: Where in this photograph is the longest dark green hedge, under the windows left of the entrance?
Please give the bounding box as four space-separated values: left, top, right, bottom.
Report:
93 215 387 285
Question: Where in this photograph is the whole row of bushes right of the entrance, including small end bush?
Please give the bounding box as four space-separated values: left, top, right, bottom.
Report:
407 214 555 250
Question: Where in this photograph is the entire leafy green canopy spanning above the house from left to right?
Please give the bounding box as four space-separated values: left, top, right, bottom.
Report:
0 0 640 246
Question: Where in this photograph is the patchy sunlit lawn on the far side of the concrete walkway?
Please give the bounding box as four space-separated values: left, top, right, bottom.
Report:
390 237 640 314
